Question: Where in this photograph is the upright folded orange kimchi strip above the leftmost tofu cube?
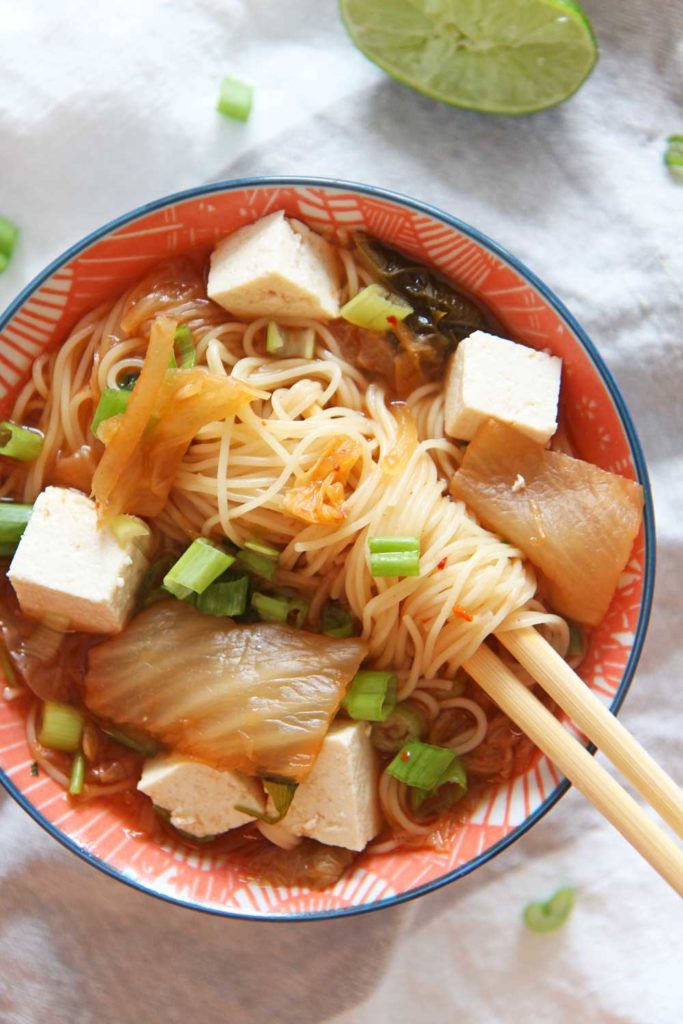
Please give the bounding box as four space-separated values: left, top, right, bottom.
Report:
92 316 263 523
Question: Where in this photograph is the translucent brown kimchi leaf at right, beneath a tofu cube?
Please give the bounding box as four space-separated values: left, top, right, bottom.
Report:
451 420 643 626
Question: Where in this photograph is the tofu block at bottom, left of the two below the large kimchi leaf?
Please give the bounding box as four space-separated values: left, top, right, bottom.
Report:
137 754 265 837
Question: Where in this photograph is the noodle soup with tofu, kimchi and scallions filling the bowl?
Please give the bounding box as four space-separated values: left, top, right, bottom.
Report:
0 195 642 909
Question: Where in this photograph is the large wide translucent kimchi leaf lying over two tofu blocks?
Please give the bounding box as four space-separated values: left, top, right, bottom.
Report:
85 600 368 782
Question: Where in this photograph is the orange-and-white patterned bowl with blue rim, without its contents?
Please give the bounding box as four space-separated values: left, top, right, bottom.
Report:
0 178 654 921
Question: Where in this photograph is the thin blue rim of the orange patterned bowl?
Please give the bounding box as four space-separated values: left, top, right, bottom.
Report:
0 175 655 923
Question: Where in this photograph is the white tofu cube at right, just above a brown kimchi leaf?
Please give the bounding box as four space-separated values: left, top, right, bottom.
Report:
444 331 562 444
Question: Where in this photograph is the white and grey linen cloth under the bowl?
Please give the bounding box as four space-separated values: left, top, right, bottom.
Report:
0 0 683 1024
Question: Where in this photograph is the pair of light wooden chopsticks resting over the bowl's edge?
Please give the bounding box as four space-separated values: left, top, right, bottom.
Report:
463 627 683 896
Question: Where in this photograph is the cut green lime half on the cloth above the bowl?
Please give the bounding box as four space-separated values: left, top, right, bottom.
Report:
340 0 598 114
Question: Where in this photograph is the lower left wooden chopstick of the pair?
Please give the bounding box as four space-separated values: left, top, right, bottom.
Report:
463 644 683 896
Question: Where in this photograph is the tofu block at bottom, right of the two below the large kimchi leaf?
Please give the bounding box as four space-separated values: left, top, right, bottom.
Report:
282 722 382 850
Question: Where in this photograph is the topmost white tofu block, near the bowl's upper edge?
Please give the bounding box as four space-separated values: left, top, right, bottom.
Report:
207 210 340 319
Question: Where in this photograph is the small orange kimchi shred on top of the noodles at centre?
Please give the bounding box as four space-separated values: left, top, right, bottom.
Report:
284 437 360 525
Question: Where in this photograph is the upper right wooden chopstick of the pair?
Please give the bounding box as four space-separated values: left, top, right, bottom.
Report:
496 626 683 839
